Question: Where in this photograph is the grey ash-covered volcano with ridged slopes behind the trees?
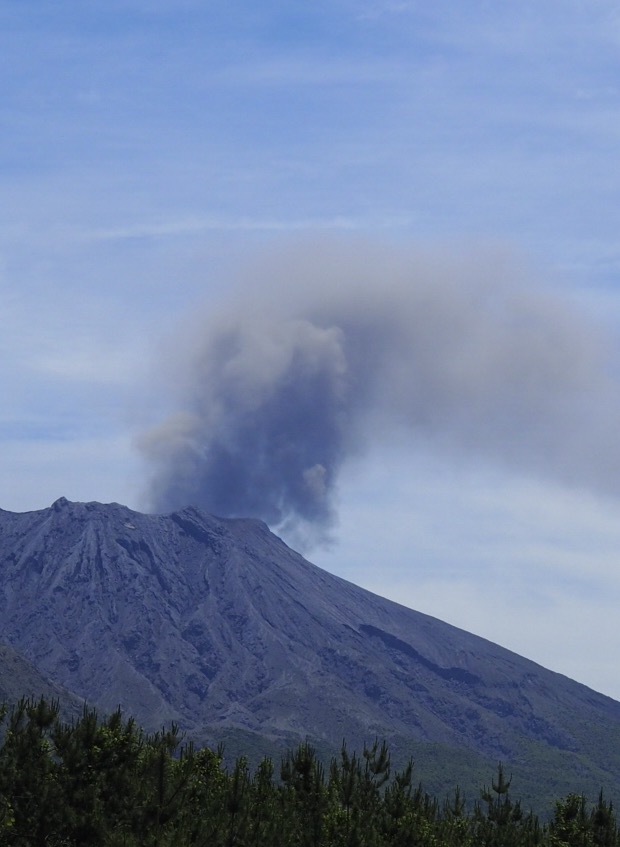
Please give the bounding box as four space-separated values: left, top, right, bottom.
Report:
0 498 620 808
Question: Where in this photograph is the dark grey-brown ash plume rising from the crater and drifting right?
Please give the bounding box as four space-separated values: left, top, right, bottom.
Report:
141 242 620 540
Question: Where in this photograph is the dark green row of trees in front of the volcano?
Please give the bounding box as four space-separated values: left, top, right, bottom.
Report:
0 699 620 847
